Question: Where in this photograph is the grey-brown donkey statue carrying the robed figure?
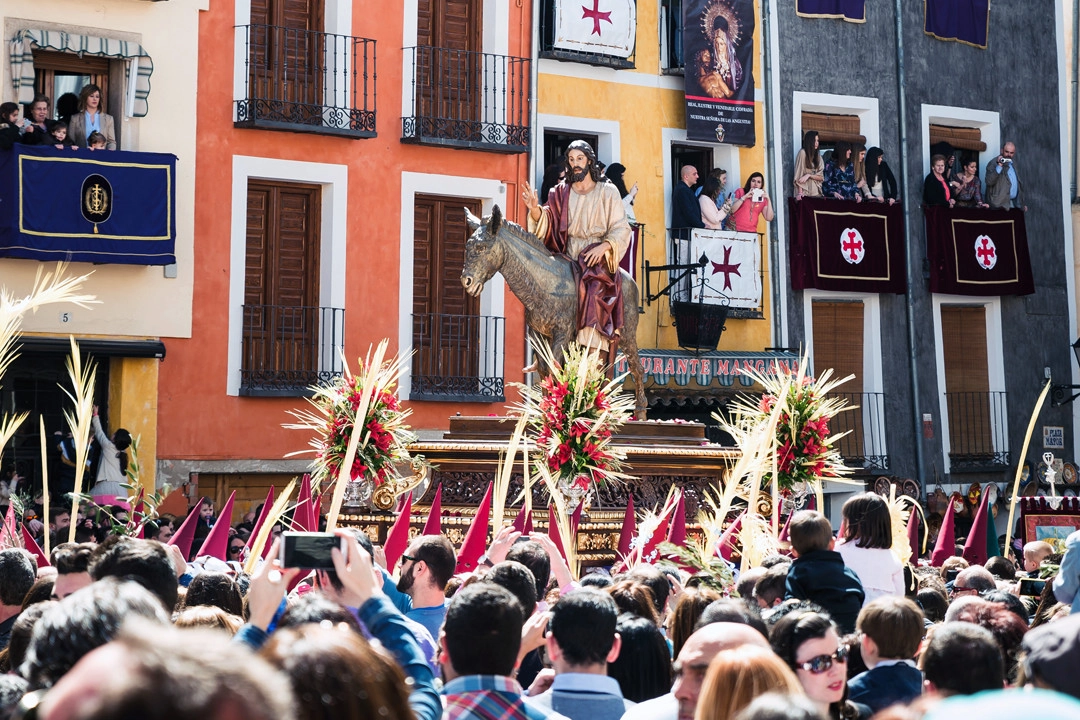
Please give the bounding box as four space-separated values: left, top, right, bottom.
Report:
461 205 648 420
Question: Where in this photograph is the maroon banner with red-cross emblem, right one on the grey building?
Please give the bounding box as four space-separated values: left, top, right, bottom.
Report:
924 207 1035 296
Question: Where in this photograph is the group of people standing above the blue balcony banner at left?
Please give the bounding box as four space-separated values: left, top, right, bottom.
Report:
0 89 118 150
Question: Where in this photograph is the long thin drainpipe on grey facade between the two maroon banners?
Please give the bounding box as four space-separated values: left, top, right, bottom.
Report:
895 0 927 498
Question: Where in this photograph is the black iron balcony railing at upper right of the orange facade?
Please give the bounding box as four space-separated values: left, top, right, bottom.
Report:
402 45 530 152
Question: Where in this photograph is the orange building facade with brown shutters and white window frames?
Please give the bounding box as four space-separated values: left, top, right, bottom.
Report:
158 0 532 507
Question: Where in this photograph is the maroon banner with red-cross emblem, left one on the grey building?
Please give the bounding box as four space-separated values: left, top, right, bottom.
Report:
787 198 907 293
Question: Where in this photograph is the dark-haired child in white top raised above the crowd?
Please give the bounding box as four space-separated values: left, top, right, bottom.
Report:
836 492 904 608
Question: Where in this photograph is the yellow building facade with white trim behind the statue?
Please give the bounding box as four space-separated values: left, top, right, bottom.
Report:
536 0 782 371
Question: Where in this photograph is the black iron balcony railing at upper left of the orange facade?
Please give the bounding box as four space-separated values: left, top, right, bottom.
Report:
234 25 375 138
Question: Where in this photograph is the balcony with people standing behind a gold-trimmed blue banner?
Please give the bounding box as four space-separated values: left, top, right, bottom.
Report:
0 100 176 266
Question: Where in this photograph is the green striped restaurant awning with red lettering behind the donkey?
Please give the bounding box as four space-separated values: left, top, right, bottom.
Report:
616 350 799 390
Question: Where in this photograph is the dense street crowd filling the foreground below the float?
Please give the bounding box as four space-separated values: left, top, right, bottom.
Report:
0 483 1080 720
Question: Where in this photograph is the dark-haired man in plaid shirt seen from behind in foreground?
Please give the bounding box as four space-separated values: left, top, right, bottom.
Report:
438 582 566 720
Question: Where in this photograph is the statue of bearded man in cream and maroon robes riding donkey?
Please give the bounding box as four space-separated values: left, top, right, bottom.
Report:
522 140 631 361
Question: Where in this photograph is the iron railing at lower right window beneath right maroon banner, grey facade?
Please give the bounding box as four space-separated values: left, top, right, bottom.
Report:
945 392 1010 471
